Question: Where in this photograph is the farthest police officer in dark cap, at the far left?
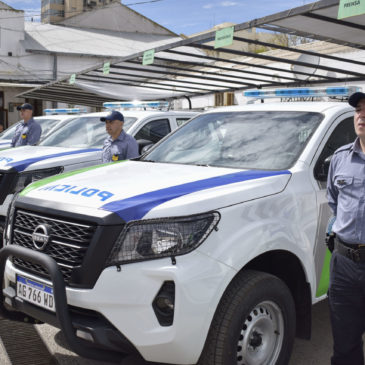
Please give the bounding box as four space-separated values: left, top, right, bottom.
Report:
11 103 42 147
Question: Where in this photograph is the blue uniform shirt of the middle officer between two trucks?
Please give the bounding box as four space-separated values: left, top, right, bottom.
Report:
103 130 139 162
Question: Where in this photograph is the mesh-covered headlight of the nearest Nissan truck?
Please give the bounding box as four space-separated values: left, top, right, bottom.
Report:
107 212 220 266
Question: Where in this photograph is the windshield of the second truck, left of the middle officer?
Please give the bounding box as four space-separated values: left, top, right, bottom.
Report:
39 116 137 148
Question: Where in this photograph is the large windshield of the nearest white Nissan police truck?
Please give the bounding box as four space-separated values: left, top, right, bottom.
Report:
143 111 323 170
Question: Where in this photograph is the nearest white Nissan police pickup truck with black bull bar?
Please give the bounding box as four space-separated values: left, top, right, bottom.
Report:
0 88 355 365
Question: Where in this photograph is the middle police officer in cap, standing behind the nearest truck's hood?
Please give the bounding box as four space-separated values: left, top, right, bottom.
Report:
100 110 139 162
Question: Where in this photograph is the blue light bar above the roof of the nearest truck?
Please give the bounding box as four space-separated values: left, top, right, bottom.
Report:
243 86 361 99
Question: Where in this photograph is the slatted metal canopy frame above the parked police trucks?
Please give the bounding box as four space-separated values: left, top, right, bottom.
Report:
19 0 365 107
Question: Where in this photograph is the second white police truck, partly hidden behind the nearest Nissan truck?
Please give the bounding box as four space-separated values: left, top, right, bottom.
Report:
0 110 198 233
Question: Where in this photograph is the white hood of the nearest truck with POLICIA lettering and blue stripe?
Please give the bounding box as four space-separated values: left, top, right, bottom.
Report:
21 161 291 222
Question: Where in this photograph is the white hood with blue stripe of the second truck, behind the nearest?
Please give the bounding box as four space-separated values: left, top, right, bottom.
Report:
0 146 101 172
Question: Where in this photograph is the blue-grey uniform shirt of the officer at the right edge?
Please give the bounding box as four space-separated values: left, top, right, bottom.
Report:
327 138 365 244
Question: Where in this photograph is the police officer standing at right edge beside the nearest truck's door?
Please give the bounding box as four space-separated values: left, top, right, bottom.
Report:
327 92 365 365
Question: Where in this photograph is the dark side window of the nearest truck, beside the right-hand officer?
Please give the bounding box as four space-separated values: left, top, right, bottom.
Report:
314 117 356 188
